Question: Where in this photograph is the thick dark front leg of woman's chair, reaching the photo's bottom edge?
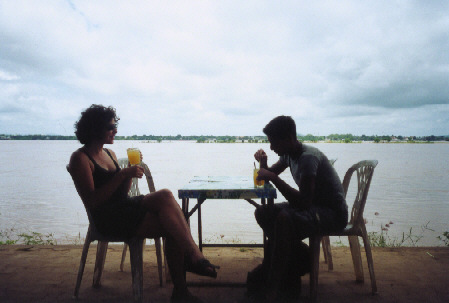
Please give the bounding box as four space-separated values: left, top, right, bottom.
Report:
128 238 143 302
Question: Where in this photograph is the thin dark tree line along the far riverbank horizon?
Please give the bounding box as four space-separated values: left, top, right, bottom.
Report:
0 134 449 143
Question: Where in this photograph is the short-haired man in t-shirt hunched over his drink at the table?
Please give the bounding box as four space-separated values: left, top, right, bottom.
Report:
249 116 348 302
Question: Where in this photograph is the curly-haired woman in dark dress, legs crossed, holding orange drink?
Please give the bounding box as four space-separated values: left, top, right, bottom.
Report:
69 104 219 302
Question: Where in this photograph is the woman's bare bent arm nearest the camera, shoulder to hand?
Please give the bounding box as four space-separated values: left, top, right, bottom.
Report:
69 151 143 209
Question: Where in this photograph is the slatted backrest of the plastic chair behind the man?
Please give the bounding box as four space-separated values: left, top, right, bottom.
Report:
343 160 378 226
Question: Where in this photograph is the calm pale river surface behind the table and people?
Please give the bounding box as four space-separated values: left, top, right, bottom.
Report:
0 141 449 246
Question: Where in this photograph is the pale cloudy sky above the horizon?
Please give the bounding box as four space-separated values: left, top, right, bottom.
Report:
0 0 449 136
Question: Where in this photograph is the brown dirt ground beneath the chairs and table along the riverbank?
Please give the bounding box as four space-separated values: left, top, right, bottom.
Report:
0 245 449 303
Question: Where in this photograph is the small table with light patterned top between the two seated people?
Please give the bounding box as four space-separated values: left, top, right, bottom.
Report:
178 176 277 251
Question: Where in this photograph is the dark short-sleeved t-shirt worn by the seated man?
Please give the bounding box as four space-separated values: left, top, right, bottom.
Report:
279 144 348 212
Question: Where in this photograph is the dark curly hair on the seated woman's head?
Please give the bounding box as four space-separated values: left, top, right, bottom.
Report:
74 104 120 144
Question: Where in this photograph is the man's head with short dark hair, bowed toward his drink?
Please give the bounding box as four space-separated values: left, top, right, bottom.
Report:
263 116 297 155
